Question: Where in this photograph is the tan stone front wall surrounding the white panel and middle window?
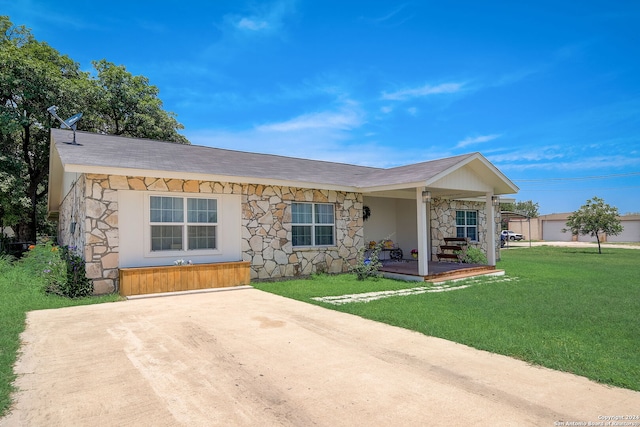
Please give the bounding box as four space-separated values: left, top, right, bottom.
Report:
59 174 364 294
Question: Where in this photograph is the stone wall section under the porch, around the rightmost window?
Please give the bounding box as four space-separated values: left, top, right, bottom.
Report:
431 198 500 261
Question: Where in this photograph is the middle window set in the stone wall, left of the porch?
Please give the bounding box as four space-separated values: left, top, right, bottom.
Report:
291 203 335 246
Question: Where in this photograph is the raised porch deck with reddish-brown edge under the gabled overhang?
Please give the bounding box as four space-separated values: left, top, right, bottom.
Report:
380 260 504 282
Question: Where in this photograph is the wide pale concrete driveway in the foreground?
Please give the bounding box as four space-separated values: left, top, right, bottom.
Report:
0 288 640 426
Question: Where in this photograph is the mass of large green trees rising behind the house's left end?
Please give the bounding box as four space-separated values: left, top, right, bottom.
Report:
0 16 189 241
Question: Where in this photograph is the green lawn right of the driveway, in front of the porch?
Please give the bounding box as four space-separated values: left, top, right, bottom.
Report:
254 246 640 390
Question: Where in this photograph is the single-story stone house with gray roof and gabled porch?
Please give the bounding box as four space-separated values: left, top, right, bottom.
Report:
49 129 518 294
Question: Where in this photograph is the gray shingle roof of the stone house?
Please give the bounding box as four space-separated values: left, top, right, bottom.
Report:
51 129 477 188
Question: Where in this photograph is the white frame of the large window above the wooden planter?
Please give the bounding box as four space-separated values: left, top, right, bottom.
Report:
143 192 223 258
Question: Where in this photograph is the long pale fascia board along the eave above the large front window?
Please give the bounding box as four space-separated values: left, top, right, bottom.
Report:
64 164 361 193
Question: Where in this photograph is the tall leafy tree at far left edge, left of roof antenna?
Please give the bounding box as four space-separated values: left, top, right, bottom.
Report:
0 16 86 241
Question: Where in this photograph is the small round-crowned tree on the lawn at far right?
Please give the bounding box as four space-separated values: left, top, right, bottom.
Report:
562 197 622 254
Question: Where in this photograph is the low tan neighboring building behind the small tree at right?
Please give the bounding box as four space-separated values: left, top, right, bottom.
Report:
509 212 640 242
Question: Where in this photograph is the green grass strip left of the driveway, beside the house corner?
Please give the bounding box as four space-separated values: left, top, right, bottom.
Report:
0 257 119 417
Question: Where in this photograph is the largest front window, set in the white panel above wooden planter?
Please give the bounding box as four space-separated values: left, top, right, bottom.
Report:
149 196 218 252
